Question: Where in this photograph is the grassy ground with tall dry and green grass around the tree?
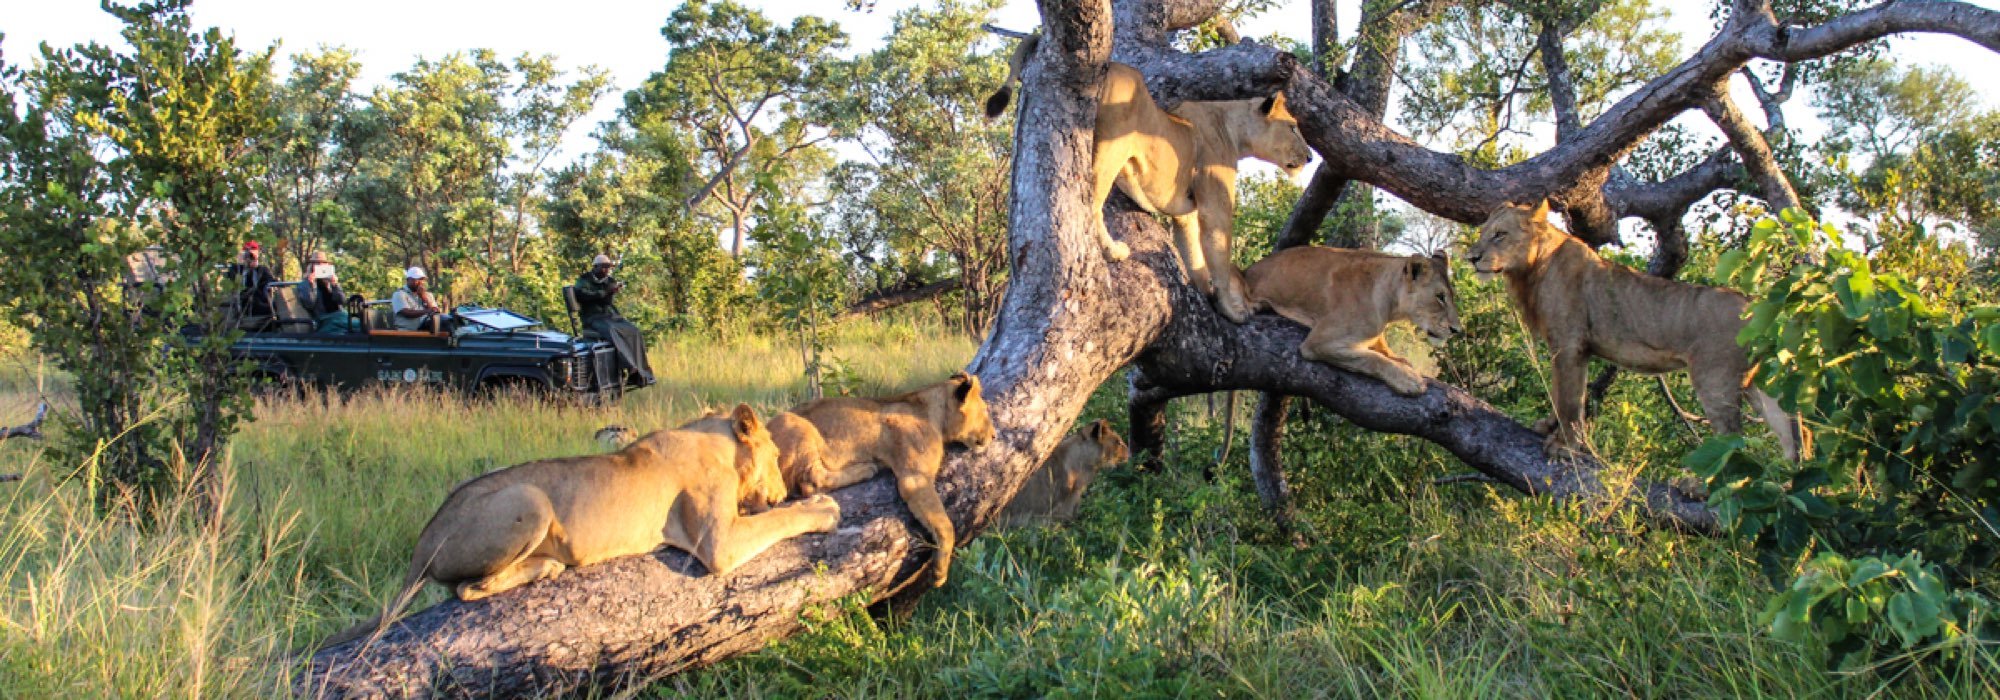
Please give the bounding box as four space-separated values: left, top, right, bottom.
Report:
0 282 2000 698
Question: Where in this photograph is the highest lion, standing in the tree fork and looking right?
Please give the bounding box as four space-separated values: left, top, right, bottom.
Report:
986 34 1312 324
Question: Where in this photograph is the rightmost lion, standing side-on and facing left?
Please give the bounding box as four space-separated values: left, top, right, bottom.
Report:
1466 200 1800 460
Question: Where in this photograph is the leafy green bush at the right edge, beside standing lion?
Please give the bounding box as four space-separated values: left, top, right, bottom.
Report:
1684 210 2000 664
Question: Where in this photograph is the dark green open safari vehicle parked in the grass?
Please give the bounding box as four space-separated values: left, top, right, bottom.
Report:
220 294 624 400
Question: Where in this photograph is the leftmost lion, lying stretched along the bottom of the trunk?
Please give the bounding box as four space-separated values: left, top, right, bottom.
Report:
320 404 840 648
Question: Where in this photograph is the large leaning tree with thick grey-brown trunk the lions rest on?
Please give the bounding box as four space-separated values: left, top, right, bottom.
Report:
300 0 2000 694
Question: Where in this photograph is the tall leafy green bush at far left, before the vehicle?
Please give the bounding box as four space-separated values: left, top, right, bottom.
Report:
0 2 272 508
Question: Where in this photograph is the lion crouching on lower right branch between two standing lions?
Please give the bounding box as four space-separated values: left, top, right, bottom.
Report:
1244 246 1460 396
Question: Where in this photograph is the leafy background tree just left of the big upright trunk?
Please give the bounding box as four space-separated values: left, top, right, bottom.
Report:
818 0 1014 338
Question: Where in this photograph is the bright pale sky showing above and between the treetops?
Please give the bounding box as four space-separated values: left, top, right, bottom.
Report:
0 0 2000 175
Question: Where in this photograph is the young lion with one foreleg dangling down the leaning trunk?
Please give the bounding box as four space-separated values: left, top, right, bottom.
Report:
776 372 994 586
